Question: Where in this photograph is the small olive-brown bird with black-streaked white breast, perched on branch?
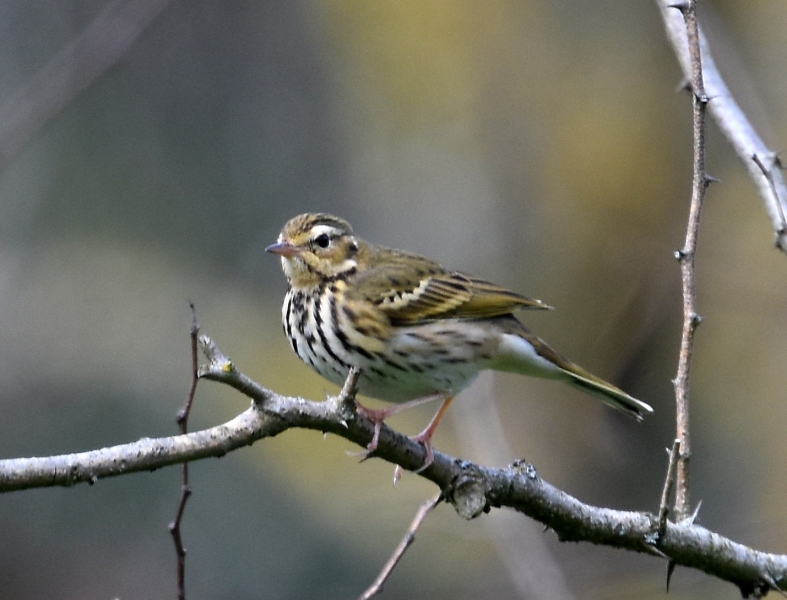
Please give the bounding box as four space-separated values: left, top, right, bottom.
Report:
266 213 653 471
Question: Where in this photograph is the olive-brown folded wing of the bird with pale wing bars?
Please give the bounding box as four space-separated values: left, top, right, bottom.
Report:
352 252 550 324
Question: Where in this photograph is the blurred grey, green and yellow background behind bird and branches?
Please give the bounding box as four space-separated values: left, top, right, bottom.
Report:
0 0 787 600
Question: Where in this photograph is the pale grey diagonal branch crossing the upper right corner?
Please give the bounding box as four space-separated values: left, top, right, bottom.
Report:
657 0 787 252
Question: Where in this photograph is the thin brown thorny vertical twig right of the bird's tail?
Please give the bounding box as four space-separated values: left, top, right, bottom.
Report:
675 0 710 519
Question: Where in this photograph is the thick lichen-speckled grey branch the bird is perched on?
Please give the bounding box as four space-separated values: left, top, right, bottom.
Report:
0 336 787 597
